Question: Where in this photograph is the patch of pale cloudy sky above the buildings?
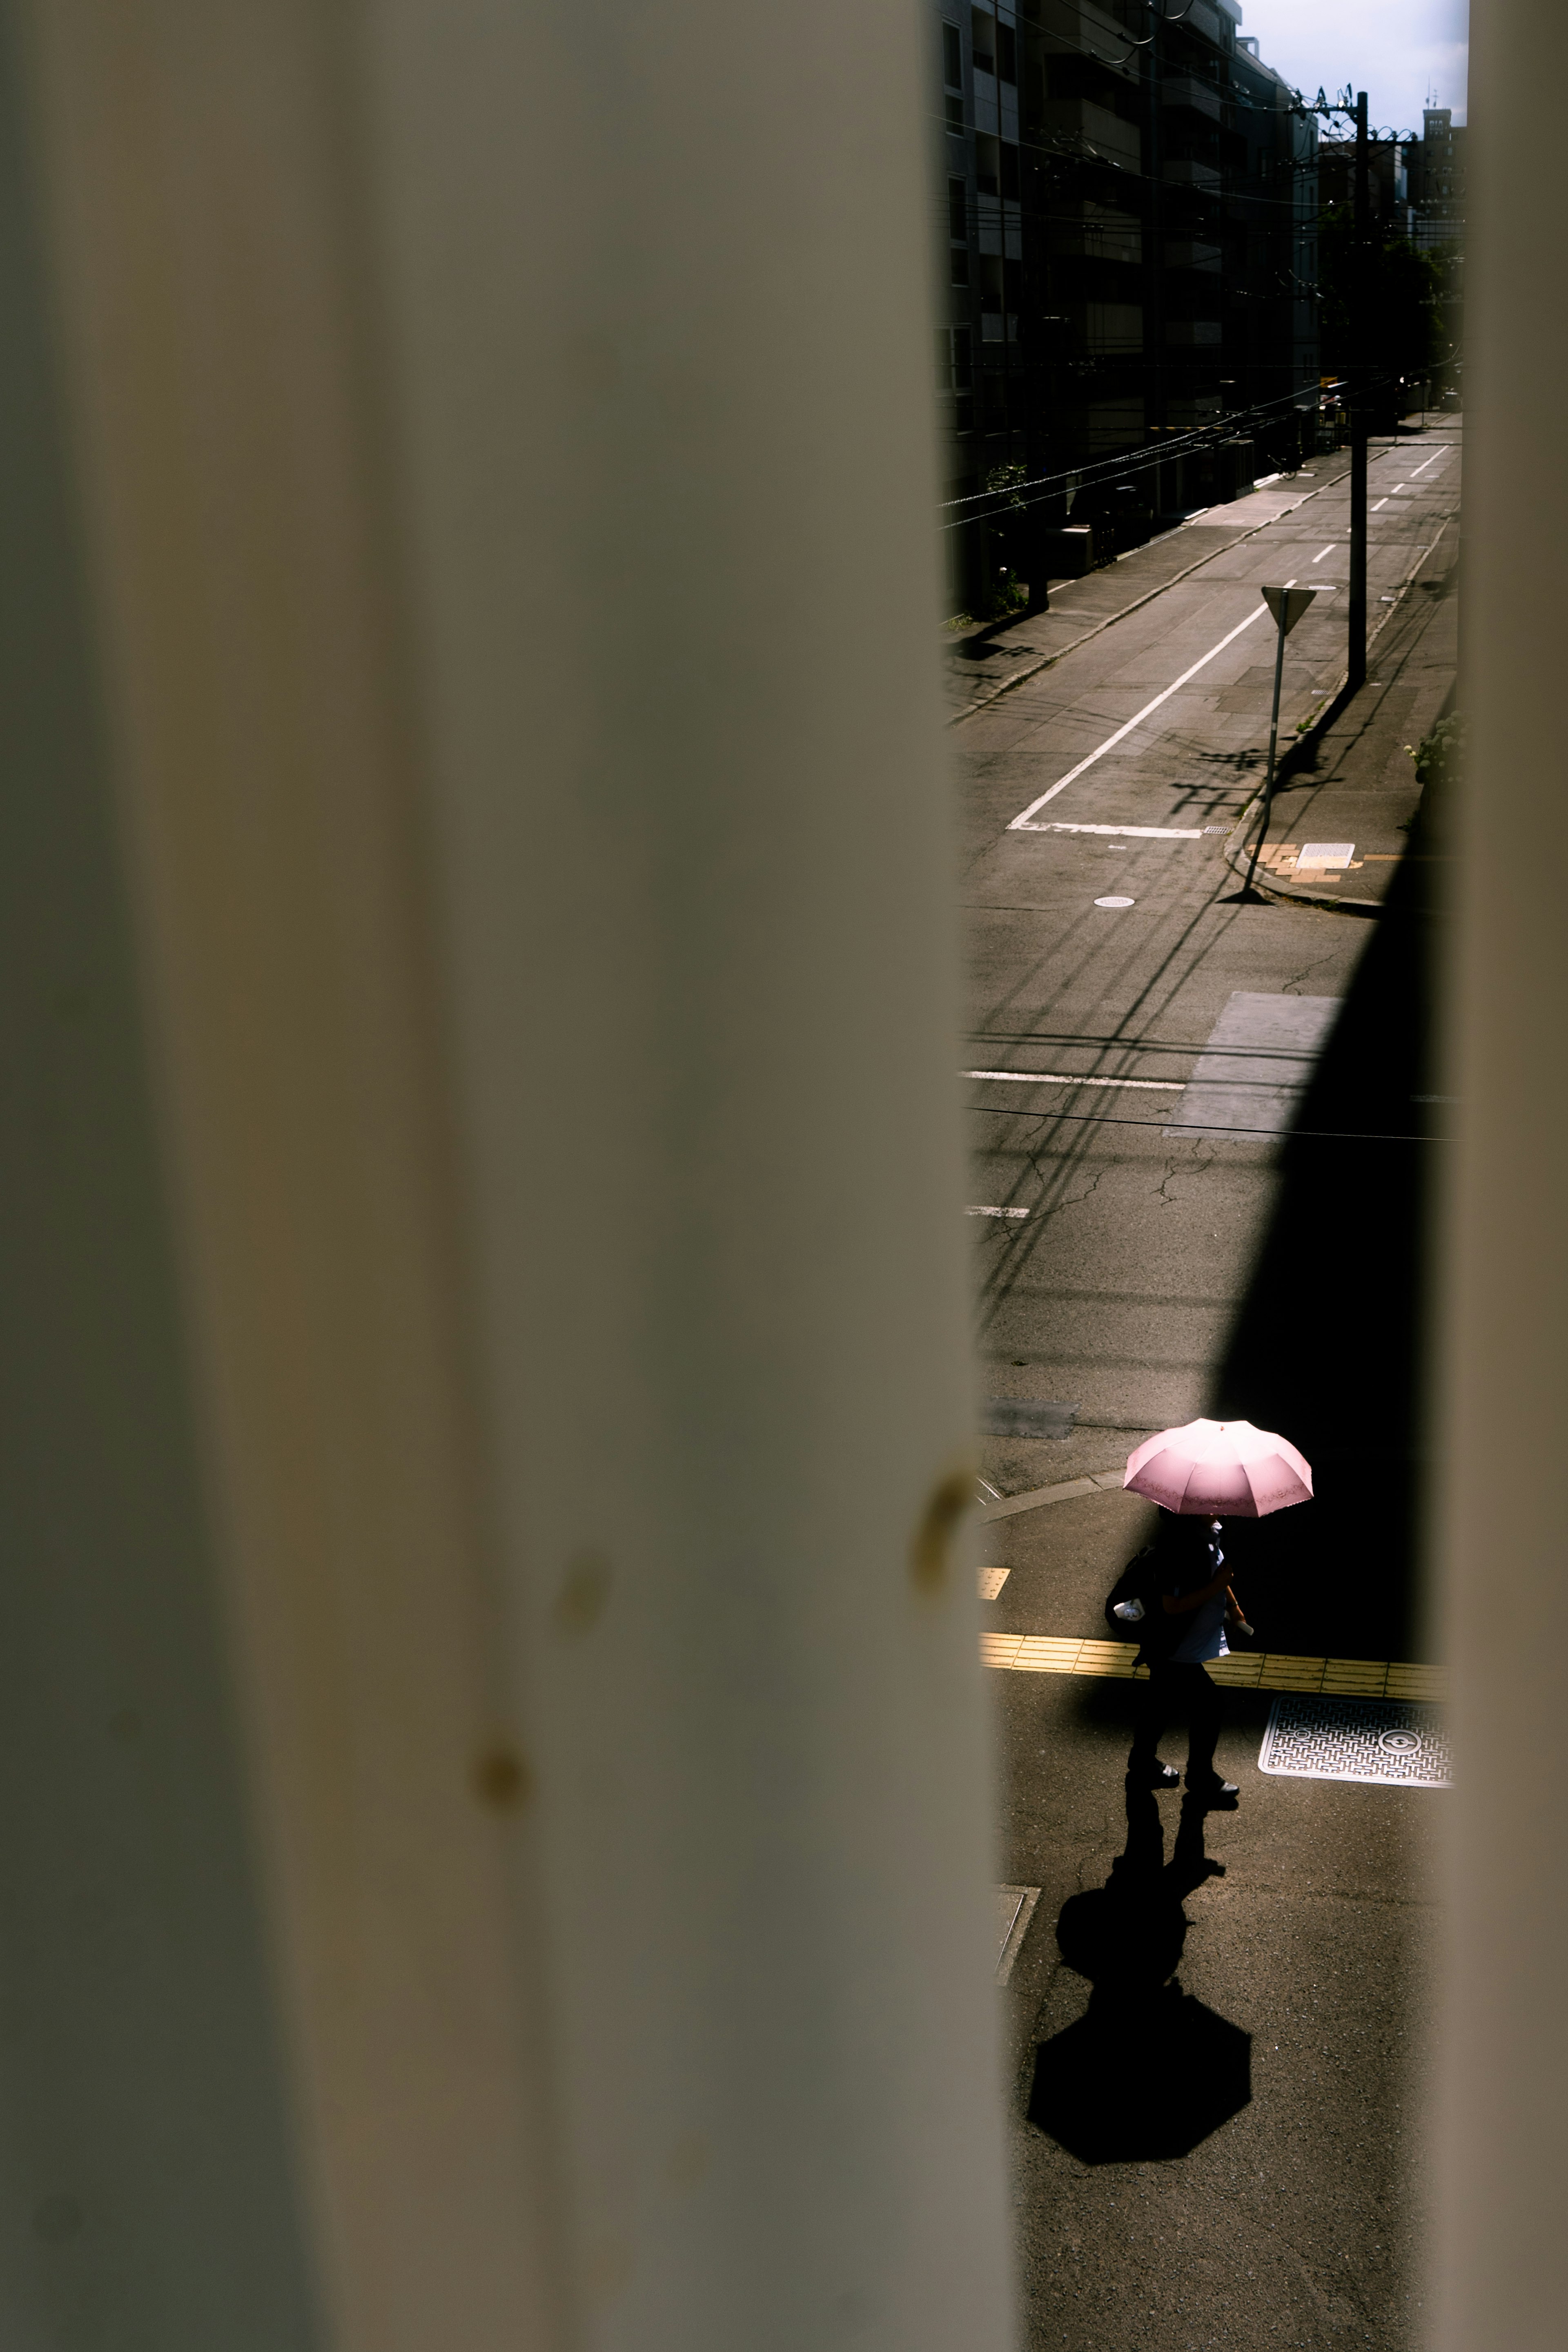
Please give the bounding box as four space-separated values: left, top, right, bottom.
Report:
1241 0 1469 134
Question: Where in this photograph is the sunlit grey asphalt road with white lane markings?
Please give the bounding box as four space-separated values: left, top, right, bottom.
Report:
957 426 1460 2352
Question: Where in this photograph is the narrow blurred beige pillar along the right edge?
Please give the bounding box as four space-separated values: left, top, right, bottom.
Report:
1439 0 1568 2352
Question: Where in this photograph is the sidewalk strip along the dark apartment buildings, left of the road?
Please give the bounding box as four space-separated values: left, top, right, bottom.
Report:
945 449 1350 725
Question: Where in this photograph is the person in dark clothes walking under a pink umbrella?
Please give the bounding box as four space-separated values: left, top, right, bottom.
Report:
1121 1420 1312 1811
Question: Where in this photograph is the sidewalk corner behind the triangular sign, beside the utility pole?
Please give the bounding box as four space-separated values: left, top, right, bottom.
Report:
1225 527 1460 915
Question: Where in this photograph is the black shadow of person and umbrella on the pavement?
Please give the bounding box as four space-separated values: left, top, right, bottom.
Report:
1030 1788 1253 2164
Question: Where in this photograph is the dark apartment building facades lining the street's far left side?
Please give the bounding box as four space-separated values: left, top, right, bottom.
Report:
931 0 1319 602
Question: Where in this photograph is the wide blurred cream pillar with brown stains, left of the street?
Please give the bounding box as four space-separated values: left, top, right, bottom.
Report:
18 0 1011 2352
